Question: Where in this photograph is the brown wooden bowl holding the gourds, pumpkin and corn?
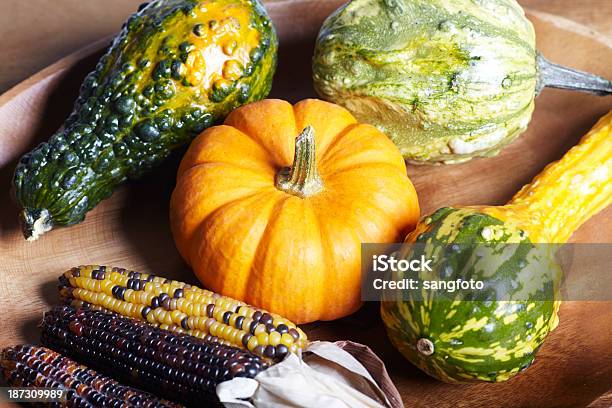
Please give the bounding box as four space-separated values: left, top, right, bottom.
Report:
0 0 612 407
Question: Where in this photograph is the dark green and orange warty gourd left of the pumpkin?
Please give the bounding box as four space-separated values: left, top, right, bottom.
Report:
14 0 277 239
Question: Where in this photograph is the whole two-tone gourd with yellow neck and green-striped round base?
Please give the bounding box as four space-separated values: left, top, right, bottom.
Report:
381 112 612 382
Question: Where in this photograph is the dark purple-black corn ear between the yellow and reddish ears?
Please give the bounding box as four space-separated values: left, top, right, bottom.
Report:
42 306 267 405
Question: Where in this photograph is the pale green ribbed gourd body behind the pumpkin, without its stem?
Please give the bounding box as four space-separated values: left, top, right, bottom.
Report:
313 0 537 163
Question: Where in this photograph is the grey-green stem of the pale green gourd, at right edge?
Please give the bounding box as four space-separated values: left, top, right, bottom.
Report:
536 52 612 96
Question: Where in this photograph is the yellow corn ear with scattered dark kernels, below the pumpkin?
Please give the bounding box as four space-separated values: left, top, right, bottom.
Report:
59 265 307 361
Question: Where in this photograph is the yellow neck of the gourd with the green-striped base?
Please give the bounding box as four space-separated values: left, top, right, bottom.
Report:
500 111 612 243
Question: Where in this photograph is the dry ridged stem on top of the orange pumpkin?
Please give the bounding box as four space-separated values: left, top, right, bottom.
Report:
276 126 323 198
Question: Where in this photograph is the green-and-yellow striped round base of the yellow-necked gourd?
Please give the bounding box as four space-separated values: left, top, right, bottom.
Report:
381 208 562 382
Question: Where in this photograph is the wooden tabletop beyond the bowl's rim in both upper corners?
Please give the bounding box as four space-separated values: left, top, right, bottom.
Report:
0 0 612 93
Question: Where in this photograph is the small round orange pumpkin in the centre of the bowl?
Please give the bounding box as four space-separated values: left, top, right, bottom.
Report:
170 99 419 323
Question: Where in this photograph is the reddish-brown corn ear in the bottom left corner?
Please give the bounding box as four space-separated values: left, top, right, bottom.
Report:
0 345 180 408
